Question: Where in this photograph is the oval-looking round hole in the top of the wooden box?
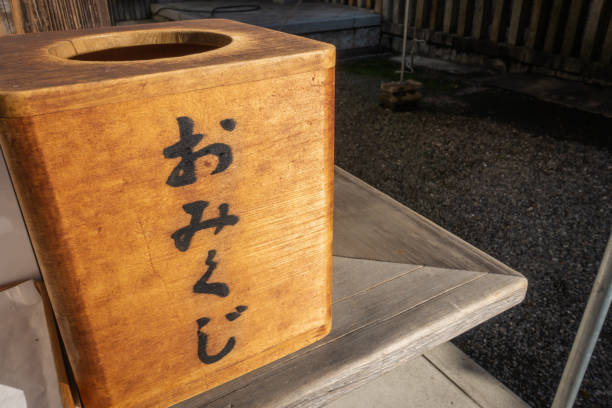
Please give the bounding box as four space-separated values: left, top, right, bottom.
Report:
49 31 232 62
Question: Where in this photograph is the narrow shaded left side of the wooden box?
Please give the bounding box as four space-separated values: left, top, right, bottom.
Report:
0 118 110 404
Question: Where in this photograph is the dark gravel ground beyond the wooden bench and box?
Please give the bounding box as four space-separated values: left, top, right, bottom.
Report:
336 57 612 407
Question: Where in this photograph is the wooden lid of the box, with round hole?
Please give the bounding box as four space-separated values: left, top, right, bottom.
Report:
0 19 335 117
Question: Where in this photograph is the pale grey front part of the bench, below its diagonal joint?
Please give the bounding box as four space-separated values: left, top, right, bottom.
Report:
176 257 525 408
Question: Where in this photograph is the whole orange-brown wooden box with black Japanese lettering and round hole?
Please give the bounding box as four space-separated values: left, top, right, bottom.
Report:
0 20 335 408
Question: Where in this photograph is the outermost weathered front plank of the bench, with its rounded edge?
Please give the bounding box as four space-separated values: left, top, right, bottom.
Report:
177 271 525 408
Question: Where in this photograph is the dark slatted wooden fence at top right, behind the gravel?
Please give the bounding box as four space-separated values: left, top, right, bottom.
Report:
327 0 612 81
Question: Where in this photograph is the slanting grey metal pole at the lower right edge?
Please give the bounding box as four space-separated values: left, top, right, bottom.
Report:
552 234 612 408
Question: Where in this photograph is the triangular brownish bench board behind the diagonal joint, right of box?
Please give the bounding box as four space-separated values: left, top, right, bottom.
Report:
333 167 520 276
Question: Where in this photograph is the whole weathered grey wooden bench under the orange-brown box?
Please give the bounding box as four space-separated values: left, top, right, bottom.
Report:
176 168 527 408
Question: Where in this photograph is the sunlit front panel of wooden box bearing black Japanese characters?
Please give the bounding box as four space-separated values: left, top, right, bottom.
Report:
17 69 334 407
